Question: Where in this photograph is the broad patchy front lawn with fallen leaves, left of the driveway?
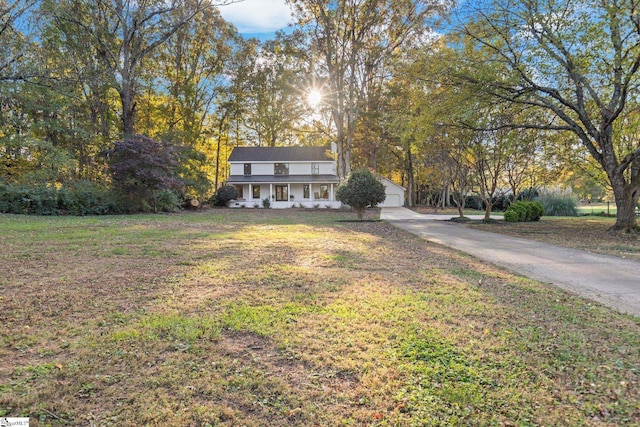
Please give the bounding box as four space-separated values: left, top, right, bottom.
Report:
0 209 640 426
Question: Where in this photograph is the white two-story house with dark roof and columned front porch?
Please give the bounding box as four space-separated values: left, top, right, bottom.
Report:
226 147 341 209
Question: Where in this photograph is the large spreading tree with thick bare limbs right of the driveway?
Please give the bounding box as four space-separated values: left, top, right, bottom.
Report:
461 0 640 231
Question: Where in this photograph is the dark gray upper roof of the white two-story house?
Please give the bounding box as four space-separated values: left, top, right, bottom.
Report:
229 147 333 162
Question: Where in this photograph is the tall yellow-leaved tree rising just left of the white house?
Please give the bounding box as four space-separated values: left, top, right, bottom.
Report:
149 3 243 197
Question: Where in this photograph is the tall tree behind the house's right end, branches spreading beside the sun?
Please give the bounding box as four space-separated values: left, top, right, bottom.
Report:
288 0 450 178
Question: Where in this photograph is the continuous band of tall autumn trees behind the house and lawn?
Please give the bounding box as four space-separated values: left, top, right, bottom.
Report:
0 0 640 226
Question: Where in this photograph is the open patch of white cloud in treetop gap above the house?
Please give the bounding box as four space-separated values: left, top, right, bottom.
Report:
219 0 292 33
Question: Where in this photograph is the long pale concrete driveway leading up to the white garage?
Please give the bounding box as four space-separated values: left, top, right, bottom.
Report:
380 208 640 316
